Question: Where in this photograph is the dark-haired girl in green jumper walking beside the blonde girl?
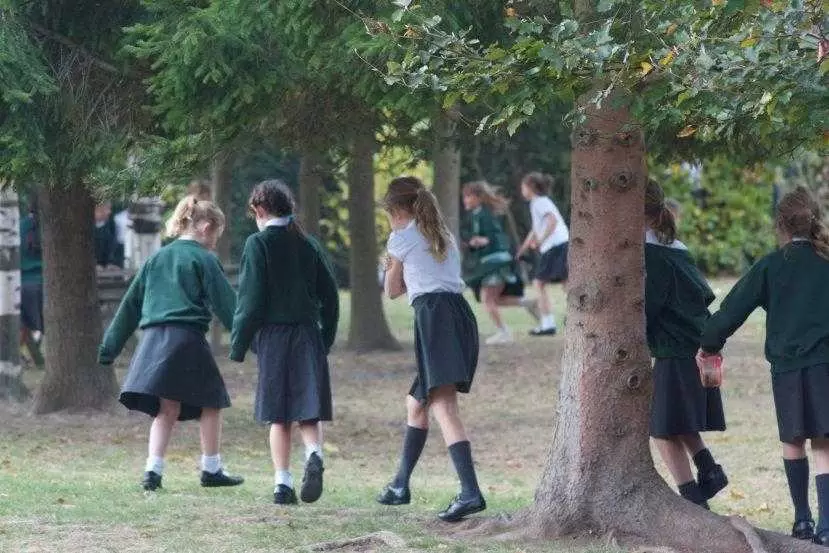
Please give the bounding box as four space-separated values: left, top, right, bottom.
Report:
230 180 339 505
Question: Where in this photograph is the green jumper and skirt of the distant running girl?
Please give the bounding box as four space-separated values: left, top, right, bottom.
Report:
461 206 524 301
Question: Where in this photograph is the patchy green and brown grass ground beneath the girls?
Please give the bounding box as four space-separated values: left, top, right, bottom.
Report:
0 282 792 553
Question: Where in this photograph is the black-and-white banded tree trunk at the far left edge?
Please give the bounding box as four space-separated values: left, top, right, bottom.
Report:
0 188 28 400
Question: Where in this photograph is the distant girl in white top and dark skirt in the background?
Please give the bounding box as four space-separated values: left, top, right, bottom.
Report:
516 173 570 336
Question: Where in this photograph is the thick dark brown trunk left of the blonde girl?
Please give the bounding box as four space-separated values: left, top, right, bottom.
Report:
34 181 116 413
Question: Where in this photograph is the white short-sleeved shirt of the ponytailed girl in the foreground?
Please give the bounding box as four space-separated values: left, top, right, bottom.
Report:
386 221 464 304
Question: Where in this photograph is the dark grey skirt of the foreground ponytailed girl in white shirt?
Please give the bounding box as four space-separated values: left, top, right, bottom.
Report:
409 292 478 402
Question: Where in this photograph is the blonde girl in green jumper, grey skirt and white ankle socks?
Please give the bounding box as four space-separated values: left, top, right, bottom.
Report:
98 196 243 491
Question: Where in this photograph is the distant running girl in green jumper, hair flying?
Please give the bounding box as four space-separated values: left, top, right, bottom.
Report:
461 181 538 344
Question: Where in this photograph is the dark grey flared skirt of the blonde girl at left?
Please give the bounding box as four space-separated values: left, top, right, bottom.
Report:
119 325 230 421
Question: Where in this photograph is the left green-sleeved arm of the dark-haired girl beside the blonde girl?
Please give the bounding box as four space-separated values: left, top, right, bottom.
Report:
230 235 267 362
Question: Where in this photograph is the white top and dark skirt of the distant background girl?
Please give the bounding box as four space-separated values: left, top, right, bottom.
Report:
530 196 570 282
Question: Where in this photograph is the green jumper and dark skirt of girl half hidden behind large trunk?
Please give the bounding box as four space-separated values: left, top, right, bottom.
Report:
645 231 725 438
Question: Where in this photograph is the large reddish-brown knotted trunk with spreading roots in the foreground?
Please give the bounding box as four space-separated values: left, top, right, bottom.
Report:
523 96 819 553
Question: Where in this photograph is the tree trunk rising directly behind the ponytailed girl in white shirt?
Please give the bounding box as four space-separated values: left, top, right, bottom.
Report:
432 109 461 236
